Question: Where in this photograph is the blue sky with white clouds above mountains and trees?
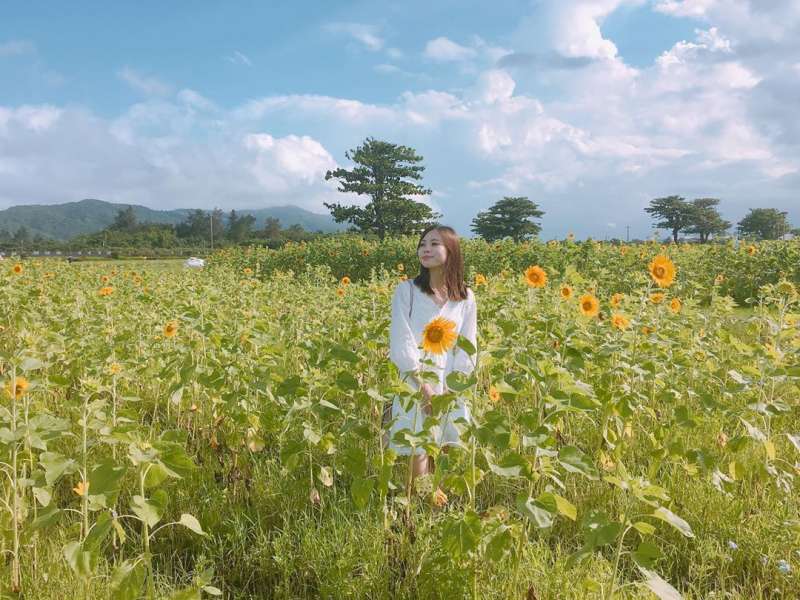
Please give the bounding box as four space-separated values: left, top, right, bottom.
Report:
0 0 800 238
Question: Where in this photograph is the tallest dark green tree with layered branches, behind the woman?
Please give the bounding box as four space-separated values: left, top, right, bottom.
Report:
325 137 441 239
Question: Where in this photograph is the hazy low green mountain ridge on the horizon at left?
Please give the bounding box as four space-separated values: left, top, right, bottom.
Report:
0 200 345 240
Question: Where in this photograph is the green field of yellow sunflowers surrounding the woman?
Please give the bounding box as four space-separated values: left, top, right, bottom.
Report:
0 236 800 600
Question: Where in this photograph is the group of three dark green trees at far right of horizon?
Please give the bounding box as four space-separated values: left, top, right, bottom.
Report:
644 196 792 243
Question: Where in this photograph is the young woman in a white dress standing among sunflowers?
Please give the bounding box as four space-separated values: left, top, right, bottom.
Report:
389 225 478 477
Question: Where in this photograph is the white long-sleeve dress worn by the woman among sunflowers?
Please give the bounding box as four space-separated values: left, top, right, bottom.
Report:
389 279 478 455
